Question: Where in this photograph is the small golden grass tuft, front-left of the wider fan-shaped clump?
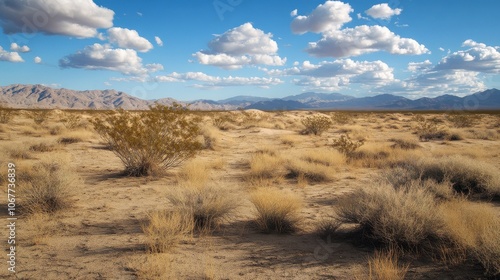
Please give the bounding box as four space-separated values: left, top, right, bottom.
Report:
142 211 194 253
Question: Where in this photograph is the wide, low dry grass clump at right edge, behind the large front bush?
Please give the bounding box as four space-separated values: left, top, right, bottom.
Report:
394 155 500 197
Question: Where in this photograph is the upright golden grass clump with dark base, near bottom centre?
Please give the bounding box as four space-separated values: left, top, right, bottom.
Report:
250 188 302 233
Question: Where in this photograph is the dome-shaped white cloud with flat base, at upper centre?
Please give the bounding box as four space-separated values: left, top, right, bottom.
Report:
193 23 286 69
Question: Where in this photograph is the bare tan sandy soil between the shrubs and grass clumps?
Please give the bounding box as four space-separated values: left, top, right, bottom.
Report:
0 111 500 279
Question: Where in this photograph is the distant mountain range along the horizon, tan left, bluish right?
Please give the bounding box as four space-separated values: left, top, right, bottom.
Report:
0 84 500 110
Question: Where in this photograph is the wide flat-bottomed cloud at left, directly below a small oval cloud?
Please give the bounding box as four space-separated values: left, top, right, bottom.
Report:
59 44 162 76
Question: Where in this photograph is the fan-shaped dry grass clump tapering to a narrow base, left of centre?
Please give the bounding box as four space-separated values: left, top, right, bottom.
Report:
167 186 238 232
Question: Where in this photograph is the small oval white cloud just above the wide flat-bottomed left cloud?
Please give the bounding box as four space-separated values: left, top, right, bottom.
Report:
108 27 153 52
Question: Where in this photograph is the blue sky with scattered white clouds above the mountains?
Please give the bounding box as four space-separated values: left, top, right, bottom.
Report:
0 0 500 100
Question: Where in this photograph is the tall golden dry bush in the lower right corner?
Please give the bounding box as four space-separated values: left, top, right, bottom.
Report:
440 199 500 275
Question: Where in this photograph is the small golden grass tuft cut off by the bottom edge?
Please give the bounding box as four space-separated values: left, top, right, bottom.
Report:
365 249 409 280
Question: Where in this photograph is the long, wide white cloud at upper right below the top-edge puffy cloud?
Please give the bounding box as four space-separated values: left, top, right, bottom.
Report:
306 25 429 57
